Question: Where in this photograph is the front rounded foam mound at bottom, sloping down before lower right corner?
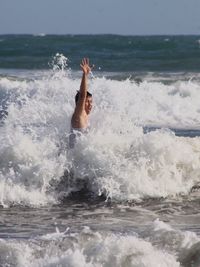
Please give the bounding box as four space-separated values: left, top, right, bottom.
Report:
0 224 183 267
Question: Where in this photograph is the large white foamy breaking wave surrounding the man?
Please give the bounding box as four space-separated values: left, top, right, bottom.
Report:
0 55 200 206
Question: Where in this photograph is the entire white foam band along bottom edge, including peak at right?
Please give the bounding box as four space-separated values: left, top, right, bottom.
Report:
0 223 200 267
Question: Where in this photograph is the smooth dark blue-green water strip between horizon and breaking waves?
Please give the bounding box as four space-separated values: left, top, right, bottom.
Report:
0 35 200 72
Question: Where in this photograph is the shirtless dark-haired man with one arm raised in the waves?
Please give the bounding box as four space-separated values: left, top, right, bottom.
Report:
69 58 92 148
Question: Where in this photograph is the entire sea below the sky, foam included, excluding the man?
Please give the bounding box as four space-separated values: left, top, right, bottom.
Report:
0 33 200 267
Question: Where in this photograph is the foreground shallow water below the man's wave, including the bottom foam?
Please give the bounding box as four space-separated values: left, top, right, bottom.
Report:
0 198 200 266
